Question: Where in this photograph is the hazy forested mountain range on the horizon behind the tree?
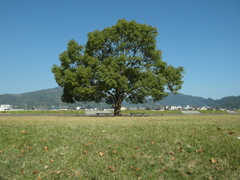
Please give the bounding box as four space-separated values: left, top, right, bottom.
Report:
0 87 240 109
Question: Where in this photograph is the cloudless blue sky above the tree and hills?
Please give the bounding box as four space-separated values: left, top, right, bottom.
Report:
0 0 240 99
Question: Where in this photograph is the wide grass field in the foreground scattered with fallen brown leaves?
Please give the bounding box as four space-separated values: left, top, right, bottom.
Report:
0 114 240 180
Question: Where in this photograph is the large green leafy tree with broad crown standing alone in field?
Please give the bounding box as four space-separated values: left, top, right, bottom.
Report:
52 19 184 116
